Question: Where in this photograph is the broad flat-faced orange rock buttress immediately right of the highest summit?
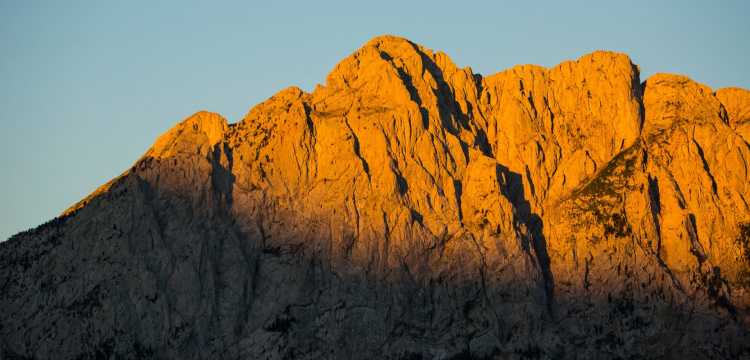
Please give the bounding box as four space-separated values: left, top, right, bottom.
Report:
481 52 642 211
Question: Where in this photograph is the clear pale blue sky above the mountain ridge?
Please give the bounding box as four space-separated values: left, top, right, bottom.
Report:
0 0 750 241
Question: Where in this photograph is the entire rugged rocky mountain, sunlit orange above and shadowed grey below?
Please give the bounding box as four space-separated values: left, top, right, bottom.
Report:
0 36 750 359
